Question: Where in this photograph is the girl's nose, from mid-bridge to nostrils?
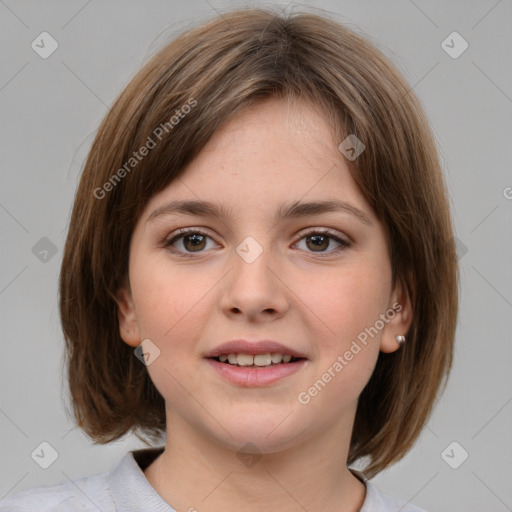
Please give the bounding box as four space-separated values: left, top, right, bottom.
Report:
220 239 290 321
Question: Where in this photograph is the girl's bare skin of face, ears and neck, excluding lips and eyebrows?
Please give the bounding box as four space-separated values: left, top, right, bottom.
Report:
118 98 412 512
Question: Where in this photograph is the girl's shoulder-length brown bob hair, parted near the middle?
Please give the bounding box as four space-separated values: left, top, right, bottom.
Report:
60 9 458 477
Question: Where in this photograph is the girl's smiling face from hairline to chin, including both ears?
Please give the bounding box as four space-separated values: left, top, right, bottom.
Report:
118 99 410 453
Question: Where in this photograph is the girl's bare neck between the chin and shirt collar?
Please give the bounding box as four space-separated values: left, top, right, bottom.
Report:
144 411 365 512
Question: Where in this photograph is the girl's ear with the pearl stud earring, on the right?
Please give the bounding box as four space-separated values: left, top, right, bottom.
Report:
380 282 413 353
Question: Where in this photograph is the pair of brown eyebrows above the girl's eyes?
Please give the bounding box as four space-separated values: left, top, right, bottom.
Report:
146 199 373 226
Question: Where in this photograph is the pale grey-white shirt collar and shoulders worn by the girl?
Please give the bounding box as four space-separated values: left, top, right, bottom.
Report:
0 447 425 512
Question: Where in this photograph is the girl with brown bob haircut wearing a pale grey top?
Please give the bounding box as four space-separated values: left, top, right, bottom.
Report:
0 9 457 512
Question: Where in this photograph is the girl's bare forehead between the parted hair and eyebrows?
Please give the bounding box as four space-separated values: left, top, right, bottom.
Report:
141 98 371 224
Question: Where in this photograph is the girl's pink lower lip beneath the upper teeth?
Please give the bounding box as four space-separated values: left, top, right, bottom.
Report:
207 359 307 388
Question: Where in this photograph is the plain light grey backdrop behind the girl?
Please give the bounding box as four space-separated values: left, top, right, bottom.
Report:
0 0 512 512
